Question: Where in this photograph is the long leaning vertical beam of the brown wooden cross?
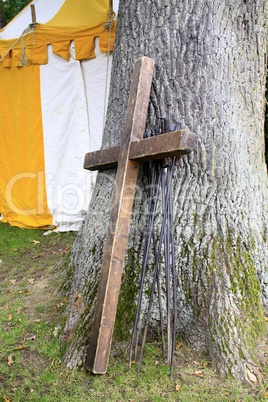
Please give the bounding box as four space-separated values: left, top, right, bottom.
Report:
86 57 154 374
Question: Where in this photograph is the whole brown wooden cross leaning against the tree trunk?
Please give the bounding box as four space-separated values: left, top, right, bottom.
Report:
84 57 195 374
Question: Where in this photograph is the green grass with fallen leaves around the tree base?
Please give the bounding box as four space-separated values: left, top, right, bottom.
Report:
0 223 268 402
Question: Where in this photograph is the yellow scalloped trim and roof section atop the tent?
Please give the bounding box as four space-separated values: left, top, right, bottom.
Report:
0 0 116 67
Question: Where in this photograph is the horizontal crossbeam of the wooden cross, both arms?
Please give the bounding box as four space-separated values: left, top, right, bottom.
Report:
84 130 195 170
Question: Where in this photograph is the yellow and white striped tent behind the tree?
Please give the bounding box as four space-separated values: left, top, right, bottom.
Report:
0 0 117 230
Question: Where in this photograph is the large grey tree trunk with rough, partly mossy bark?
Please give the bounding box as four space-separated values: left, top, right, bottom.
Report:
60 0 268 382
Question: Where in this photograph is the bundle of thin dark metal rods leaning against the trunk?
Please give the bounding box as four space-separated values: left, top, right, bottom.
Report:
129 119 180 375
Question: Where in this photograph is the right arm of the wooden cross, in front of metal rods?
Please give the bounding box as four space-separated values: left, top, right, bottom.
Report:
129 130 195 162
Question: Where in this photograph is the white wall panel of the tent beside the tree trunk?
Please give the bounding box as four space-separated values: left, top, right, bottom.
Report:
40 41 111 231
